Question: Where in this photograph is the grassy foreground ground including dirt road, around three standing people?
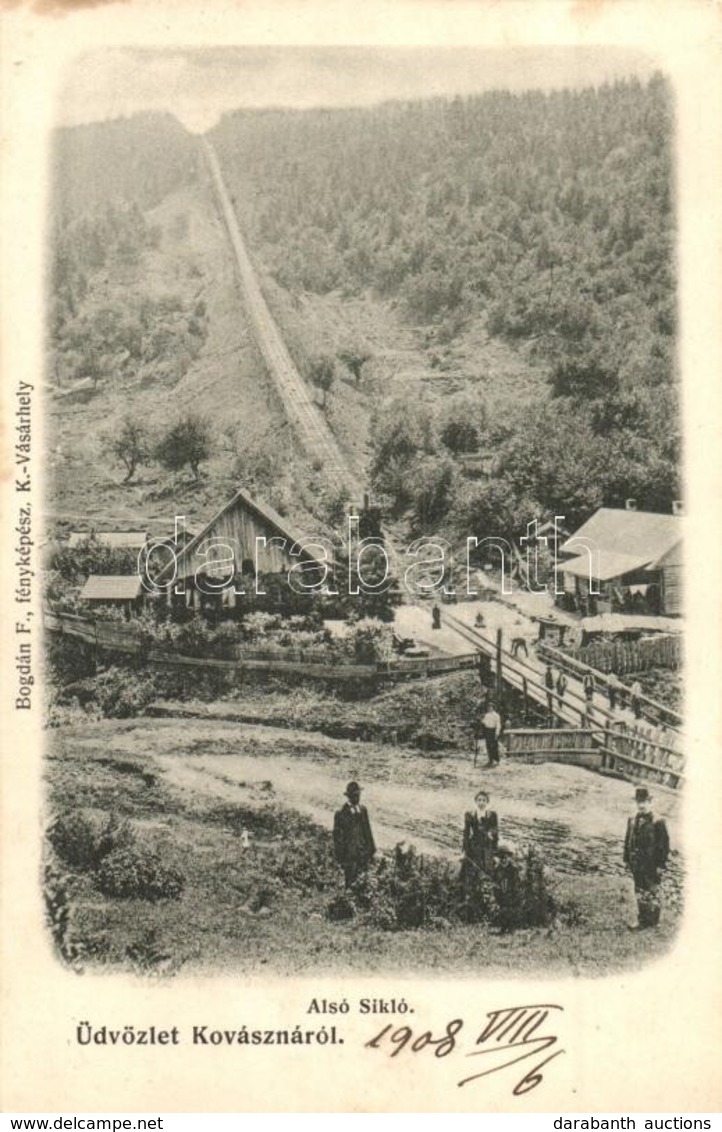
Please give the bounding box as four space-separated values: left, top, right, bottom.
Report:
48 719 680 976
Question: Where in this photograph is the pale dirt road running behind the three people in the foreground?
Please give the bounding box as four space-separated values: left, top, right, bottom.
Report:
57 720 679 892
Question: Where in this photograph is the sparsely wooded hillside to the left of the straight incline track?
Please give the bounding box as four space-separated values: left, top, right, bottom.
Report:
46 114 314 532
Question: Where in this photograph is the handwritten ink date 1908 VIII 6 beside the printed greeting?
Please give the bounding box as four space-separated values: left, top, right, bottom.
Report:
366 1003 565 1097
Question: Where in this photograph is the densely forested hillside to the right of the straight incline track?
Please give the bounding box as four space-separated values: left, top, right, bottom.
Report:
212 76 679 529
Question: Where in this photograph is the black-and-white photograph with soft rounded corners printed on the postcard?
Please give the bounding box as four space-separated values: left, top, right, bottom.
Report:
43 48 685 975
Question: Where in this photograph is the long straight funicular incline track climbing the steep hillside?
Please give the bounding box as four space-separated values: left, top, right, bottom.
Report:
201 138 362 499
